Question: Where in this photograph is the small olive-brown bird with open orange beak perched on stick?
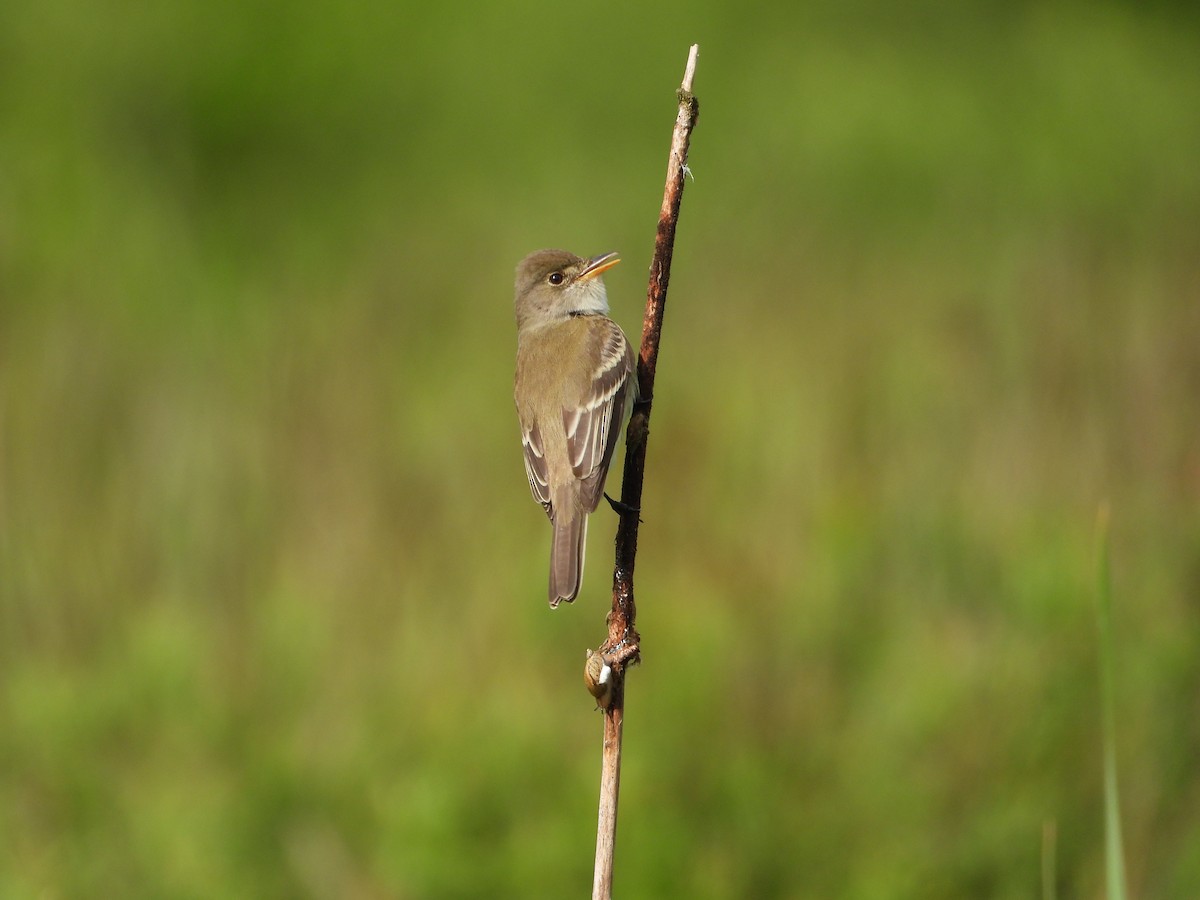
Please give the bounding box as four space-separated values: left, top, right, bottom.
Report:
514 250 637 607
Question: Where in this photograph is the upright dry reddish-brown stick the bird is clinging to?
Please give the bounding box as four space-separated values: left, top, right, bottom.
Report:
592 44 700 900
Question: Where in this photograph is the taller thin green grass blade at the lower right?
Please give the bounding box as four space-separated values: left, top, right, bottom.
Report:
1096 505 1127 900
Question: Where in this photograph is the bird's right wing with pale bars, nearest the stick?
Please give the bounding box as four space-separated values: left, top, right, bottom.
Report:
563 318 634 512
